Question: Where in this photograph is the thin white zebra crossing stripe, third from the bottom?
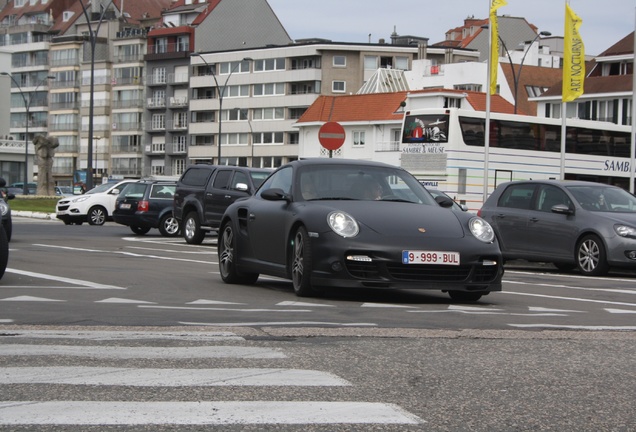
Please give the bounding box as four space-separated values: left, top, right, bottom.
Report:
0 344 287 360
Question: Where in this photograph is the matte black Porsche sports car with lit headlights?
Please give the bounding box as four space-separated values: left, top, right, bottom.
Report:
218 158 503 301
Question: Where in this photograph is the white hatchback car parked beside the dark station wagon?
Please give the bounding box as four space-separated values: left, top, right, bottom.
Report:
55 180 137 225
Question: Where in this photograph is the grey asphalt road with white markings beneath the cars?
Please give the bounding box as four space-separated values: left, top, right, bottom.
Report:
0 218 636 431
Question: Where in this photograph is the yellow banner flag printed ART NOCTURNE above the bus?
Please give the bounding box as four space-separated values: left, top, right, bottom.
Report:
562 3 585 102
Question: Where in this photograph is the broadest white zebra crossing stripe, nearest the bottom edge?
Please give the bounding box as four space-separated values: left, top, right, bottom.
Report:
0 401 424 426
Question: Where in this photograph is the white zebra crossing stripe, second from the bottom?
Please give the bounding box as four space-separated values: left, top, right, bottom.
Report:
0 366 351 387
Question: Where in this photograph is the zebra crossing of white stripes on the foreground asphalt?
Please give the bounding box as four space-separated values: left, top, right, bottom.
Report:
0 330 424 430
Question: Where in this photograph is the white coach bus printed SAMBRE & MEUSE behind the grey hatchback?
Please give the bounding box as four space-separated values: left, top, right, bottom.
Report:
400 108 631 210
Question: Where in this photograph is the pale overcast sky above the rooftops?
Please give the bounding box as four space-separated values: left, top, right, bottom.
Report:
268 0 636 55
